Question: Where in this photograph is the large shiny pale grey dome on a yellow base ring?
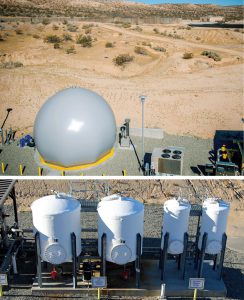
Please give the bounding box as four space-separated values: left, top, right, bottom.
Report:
34 88 116 167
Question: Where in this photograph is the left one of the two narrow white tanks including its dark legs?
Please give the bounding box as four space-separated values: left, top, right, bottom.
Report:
159 198 191 281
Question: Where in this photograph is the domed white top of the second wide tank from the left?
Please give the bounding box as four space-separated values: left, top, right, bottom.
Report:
97 194 144 217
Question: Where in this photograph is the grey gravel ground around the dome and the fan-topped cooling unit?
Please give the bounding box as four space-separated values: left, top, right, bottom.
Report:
0 133 213 176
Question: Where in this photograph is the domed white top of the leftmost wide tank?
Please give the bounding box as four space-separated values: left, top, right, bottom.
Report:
31 194 80 215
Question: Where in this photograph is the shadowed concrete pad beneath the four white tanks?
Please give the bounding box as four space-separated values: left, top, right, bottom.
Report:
32 260 227 297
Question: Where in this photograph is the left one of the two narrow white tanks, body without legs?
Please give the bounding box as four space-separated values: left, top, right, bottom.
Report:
161 198 191 254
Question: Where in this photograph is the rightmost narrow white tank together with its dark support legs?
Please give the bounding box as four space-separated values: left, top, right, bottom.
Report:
195 198 230 279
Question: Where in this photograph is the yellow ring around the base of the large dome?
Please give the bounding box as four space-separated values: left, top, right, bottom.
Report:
40 148 114 171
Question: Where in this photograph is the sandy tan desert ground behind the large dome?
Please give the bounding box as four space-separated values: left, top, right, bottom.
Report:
0 22 244 138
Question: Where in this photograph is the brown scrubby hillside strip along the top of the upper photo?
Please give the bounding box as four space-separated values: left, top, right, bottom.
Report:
0 0 243 20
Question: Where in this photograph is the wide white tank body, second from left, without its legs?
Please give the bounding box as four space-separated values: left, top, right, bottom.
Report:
97 195 144 265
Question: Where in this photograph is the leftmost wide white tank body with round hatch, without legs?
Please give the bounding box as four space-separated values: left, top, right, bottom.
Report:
31 194 81 265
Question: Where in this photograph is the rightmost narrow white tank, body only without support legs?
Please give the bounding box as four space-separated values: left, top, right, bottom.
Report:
198 198 230 254
